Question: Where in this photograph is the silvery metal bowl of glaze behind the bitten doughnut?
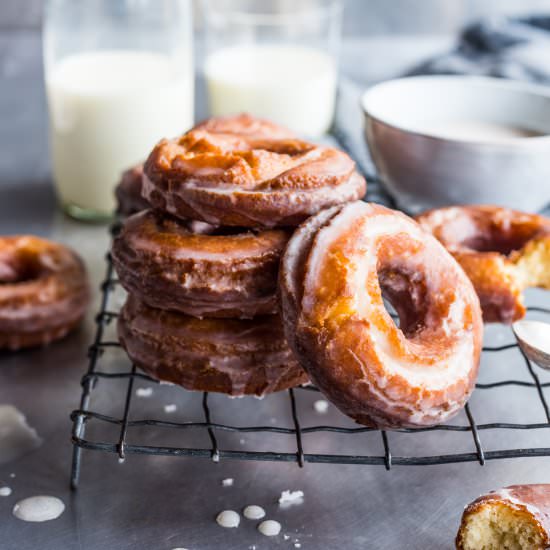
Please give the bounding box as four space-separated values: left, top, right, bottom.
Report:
361 76 550 214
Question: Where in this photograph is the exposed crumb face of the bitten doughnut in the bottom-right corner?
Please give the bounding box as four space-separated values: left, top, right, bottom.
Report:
459 502 545 550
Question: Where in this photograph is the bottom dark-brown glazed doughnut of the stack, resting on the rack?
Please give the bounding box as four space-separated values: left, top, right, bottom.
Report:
118 295 307 396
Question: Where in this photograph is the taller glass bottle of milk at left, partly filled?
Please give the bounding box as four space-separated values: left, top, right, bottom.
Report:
43 0 194 220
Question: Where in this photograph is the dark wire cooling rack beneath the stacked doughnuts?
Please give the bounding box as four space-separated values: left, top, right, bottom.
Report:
71 183 550 488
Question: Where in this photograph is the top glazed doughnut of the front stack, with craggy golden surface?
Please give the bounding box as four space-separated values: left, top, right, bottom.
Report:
143 128 366 227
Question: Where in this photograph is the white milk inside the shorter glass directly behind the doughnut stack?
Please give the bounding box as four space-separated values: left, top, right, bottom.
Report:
205 45 337 136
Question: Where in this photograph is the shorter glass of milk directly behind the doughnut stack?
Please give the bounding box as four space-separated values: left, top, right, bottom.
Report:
203 0 342 137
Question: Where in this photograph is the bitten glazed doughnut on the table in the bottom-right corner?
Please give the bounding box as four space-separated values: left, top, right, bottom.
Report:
456 484 550 550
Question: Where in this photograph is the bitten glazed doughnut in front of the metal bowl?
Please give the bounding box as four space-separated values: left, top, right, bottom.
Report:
417 206 550 324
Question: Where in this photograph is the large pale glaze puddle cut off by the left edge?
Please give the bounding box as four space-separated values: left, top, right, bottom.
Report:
0 405 42 464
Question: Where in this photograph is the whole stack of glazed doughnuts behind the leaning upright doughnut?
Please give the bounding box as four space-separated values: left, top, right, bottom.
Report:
112 115 366 396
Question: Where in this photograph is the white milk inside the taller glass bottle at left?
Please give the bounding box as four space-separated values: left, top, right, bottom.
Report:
46 50 193 215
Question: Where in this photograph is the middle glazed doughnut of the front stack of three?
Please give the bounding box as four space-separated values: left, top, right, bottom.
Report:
112 210 289 318
